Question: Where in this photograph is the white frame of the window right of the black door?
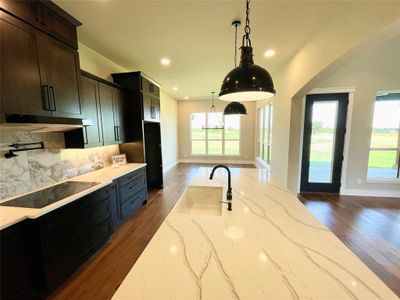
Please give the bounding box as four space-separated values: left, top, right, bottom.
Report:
366 90 400 183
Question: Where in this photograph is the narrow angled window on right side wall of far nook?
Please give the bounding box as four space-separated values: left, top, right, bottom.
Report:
258 102 273 164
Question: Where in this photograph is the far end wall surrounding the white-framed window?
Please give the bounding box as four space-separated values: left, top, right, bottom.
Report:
178 100 256 163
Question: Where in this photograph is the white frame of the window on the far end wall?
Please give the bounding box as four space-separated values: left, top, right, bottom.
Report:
190 112 242 157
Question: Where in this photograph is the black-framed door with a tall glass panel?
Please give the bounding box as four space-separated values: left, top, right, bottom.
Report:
300 93 348 193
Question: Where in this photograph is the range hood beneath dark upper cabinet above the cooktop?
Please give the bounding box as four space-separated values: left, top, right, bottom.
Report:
0 114 84 132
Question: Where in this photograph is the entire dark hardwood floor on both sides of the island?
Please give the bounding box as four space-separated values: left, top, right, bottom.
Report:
49 164 400 300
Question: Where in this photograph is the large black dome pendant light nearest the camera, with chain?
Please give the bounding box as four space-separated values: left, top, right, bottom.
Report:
219 0 276 102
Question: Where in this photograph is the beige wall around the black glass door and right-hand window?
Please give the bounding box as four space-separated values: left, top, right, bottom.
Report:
315 35 400 196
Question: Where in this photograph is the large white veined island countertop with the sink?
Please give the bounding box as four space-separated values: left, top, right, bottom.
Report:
113 168 398 300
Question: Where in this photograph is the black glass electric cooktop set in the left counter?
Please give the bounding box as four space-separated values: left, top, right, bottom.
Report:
0 181 99 208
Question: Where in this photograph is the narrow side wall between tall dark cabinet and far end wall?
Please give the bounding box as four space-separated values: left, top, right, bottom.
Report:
161 90 178 172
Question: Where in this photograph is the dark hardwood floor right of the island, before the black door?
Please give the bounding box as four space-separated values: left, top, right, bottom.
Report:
299 193 400 297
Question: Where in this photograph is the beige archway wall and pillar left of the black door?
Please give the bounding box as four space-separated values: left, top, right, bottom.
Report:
257 2 400 191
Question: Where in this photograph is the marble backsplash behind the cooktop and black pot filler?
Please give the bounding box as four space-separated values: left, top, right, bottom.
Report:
0 131 119 199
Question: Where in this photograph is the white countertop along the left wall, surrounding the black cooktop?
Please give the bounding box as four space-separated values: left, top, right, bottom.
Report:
0 163 146 229
